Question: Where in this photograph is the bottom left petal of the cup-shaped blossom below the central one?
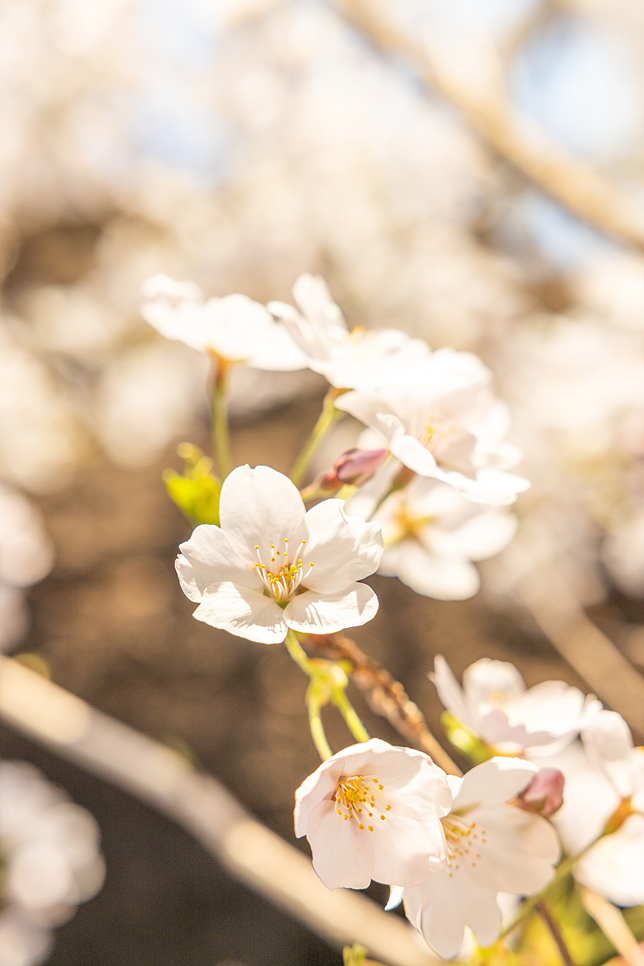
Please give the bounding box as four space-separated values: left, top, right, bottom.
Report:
306 800 375 889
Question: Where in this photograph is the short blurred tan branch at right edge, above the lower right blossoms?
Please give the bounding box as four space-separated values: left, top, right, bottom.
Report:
516 567 644 736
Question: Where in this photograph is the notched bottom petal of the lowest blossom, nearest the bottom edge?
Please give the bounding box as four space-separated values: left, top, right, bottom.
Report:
404 872 501 958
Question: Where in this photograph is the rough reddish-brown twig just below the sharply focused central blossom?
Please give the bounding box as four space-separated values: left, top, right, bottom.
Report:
304 634 462 775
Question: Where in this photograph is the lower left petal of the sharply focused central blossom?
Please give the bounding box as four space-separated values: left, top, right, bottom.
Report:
193 581 288 644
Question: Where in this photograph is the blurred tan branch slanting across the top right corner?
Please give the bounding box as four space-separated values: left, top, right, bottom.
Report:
335 0 644 249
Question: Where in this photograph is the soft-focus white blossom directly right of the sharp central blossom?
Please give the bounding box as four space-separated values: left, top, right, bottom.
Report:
347 474 517 600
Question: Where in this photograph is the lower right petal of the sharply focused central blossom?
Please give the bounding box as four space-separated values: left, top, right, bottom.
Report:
284 583 378 634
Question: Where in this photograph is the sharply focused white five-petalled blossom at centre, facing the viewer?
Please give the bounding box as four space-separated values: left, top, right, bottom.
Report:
177 465 382 644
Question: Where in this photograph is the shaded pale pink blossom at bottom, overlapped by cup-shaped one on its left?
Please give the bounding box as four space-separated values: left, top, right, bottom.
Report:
402 758 560 957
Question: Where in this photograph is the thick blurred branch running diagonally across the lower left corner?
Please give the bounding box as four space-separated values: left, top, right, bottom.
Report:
0 656 441 966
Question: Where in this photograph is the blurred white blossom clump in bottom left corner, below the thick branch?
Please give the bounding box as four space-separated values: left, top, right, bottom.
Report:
0 761 105 966
